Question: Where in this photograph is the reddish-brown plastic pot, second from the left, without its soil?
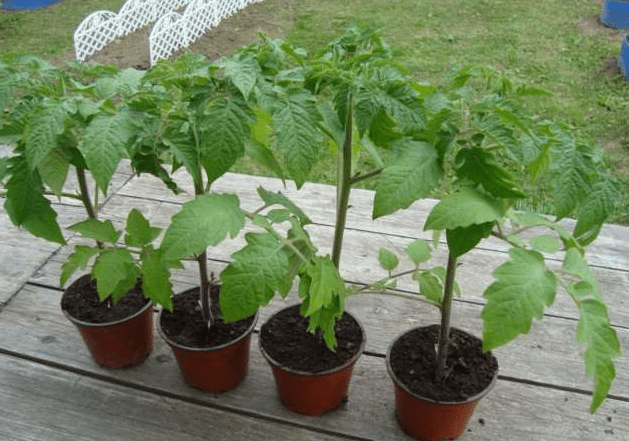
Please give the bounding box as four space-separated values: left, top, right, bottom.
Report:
157 306 258 393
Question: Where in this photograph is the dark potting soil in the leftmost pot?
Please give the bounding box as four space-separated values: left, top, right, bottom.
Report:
61 274 149 323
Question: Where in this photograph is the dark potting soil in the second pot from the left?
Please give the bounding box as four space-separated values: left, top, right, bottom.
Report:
160 285 255 348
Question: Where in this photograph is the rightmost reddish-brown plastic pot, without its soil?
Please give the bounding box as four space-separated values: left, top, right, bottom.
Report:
386 324 498 441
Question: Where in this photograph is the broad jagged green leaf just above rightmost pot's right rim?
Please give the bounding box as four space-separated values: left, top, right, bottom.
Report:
481 248 557 351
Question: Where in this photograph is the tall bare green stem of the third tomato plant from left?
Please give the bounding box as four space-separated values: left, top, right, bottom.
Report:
332 99 353 268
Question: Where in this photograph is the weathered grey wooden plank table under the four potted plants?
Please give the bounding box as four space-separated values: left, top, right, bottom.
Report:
0 167 629 441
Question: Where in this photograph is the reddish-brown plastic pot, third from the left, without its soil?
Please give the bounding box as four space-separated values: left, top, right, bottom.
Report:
258 306 365 416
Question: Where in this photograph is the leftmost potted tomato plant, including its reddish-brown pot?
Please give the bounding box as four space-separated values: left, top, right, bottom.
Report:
0 55 173 367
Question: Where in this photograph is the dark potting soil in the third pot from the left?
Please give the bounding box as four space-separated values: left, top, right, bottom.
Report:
260 305 364 373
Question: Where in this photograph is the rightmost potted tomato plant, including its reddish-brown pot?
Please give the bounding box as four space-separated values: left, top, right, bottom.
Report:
364 67 620 440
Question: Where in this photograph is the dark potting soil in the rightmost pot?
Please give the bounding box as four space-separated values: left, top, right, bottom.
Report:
391 325 498 402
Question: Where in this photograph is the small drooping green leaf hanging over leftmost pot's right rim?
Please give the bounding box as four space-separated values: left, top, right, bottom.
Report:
140 248 173 312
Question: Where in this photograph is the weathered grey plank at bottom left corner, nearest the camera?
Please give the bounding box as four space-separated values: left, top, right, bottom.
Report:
0 355 356 441
